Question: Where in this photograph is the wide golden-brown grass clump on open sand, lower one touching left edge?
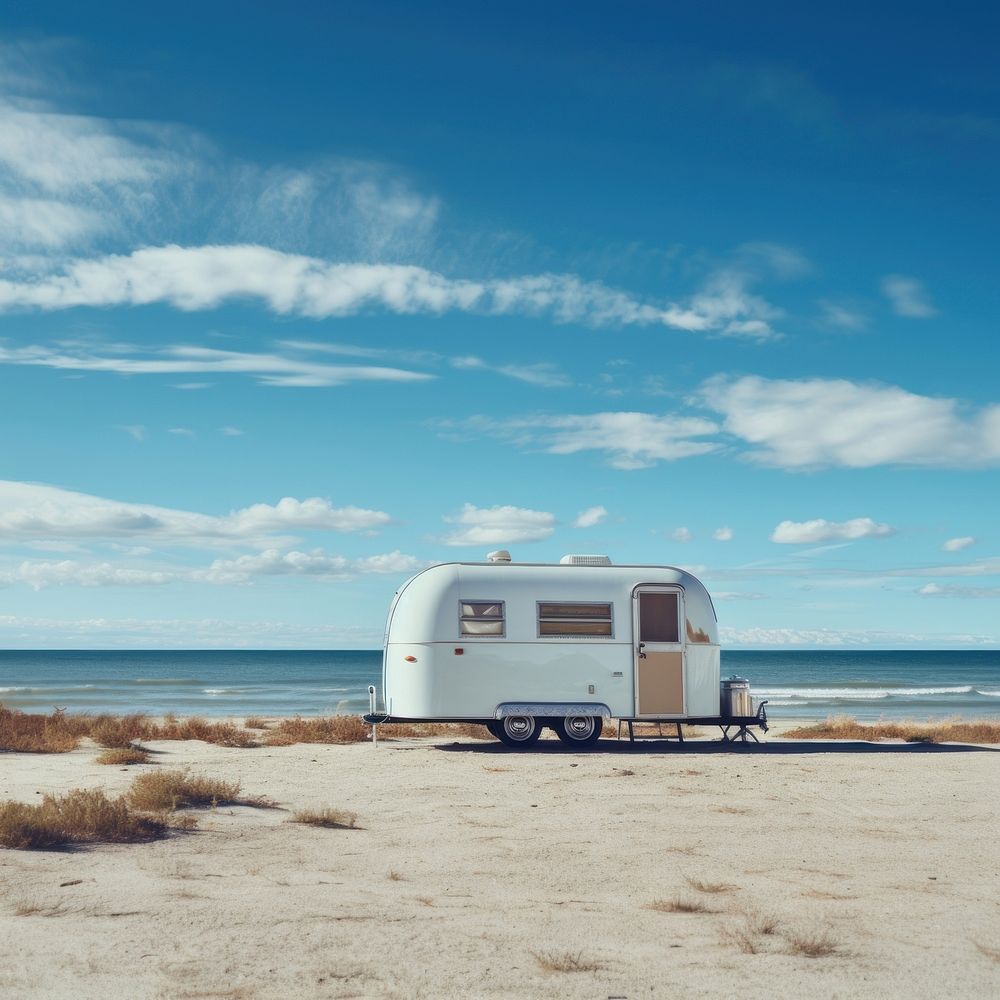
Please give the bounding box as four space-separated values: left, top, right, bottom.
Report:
0 789 166 851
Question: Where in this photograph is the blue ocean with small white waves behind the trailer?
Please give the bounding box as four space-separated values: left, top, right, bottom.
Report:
0 650 1000 720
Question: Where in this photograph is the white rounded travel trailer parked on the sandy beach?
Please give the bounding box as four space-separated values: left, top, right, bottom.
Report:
365 551 759 747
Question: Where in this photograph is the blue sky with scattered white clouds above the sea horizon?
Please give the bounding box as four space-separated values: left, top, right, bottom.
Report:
0 2 1000 648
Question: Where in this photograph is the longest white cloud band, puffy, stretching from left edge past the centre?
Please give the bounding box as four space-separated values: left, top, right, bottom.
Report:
0 244 779 340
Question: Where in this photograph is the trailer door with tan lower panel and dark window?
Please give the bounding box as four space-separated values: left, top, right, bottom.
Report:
633 585 687 717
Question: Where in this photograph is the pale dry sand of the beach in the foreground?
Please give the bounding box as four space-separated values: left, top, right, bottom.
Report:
0 731 1000 1000
